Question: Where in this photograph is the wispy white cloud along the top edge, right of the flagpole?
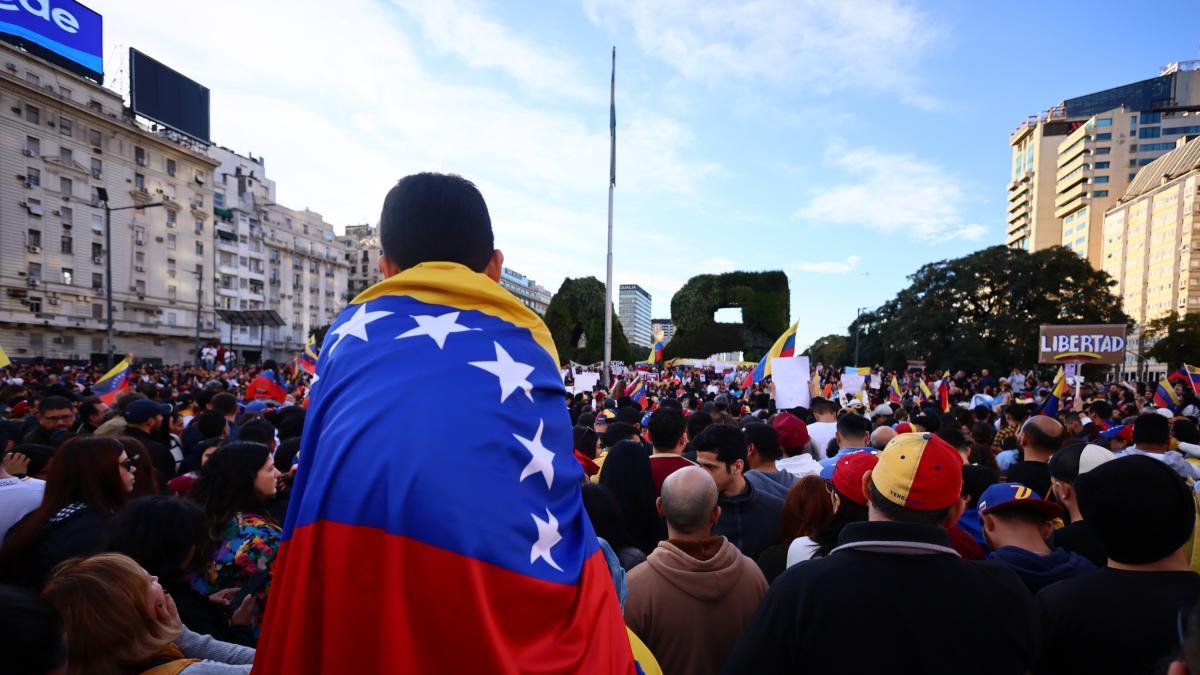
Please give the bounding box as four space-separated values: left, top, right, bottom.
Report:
583 0 942 109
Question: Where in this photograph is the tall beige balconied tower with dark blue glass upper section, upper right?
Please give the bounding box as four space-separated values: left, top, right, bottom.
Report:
1004 61 1200 263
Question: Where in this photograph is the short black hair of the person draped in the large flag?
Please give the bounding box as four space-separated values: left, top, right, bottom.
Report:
379 173 496 271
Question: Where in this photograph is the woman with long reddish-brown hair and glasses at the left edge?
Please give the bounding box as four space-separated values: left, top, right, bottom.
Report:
0 436 137 589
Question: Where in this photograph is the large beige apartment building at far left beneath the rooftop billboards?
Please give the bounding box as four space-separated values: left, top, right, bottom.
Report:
0 44 217 363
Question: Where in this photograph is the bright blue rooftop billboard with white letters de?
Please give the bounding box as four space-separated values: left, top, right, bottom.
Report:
0 0 104 82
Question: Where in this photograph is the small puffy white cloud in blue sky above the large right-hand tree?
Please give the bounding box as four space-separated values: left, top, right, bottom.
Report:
796 143 989 241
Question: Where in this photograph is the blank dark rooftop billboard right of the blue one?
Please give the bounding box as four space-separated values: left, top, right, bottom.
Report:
130 49 211 144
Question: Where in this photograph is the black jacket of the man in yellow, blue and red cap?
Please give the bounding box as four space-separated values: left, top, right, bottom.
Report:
724 521 1038 675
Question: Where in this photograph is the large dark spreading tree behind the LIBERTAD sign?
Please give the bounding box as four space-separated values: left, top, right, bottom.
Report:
850 246 1129 370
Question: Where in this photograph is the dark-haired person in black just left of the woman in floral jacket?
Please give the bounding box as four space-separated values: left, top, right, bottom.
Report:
108 495 256 647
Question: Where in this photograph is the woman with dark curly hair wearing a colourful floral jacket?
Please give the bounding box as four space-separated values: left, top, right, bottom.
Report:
191 442 282 595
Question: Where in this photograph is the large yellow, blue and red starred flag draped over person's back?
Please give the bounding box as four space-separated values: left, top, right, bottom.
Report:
254 263 635 674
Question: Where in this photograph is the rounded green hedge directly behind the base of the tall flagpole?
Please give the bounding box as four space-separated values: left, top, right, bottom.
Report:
546 276 648 363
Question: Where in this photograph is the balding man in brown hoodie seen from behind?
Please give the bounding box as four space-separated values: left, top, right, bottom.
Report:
625 466 767 675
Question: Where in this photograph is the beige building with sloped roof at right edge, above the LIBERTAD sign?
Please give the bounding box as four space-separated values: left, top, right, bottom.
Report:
1102 135 1200 362
